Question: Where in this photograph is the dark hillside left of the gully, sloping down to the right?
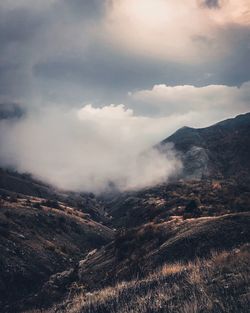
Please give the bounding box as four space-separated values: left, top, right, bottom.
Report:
0 170 114 312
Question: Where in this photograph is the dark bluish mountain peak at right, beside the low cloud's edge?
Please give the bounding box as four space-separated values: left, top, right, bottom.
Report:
159 113 250 179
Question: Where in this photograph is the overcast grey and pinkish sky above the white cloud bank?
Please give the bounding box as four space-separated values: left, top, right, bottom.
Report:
0 0 250 109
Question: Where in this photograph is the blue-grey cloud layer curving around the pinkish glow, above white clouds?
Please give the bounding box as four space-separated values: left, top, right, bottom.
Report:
0 0 250 110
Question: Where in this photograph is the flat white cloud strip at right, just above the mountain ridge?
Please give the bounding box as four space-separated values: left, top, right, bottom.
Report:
129 82 250 126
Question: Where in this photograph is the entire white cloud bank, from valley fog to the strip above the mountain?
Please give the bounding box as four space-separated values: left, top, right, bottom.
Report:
0 82 250 192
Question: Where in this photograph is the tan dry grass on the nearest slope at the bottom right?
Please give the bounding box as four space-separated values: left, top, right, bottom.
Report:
27 246 250 313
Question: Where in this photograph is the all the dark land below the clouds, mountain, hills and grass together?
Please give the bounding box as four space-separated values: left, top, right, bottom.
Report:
0 114 250 313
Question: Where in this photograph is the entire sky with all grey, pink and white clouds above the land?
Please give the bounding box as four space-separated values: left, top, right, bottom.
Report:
0 0 250 190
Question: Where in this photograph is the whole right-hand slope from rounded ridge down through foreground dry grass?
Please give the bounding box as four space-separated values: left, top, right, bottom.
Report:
25 212 250 313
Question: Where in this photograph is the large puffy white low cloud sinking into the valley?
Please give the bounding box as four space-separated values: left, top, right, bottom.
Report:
0 105 181 192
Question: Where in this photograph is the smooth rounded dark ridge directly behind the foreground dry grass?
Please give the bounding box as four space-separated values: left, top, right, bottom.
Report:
32 213 250 303
